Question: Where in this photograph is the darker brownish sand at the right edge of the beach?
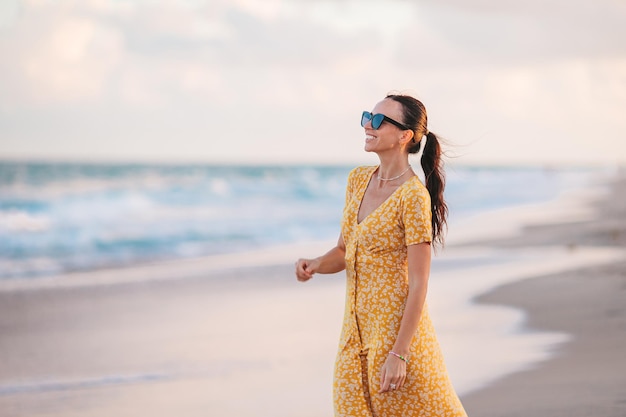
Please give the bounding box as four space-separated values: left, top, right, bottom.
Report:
463 170 626 417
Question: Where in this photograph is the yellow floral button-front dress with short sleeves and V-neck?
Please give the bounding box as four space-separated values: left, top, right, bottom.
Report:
333 167 466 417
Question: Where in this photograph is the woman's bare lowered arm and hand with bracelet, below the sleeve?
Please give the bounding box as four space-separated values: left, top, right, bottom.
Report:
380 242 431 392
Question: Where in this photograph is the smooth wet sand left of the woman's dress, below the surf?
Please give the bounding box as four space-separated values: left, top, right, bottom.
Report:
0 264 343 416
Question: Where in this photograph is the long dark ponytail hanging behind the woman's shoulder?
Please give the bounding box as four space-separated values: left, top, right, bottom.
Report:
422 132 448 245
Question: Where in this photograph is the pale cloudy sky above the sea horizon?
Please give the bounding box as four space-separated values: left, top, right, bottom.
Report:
0 0 626 165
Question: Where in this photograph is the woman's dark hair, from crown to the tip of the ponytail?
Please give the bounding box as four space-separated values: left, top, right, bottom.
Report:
385 94 448 245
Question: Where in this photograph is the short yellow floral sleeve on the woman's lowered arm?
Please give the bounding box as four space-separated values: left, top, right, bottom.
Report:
402 182 433 246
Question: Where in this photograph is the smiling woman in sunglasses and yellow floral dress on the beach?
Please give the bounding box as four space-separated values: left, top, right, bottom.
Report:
296 95 466 417
